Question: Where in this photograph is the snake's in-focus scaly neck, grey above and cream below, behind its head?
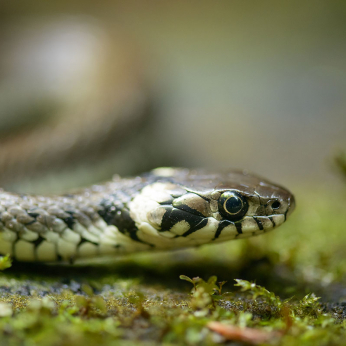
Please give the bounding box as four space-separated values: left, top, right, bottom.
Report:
0 178 149 262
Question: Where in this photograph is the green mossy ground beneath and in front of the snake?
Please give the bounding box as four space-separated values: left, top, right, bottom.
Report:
0 182 346 346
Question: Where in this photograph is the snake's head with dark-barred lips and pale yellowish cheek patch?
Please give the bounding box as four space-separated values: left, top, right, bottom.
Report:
130 168 295 248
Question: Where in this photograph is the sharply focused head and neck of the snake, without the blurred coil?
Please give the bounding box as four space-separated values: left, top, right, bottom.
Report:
0 167 295 263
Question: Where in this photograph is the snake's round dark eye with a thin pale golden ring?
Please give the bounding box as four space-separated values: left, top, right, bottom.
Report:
219 191 249 221
